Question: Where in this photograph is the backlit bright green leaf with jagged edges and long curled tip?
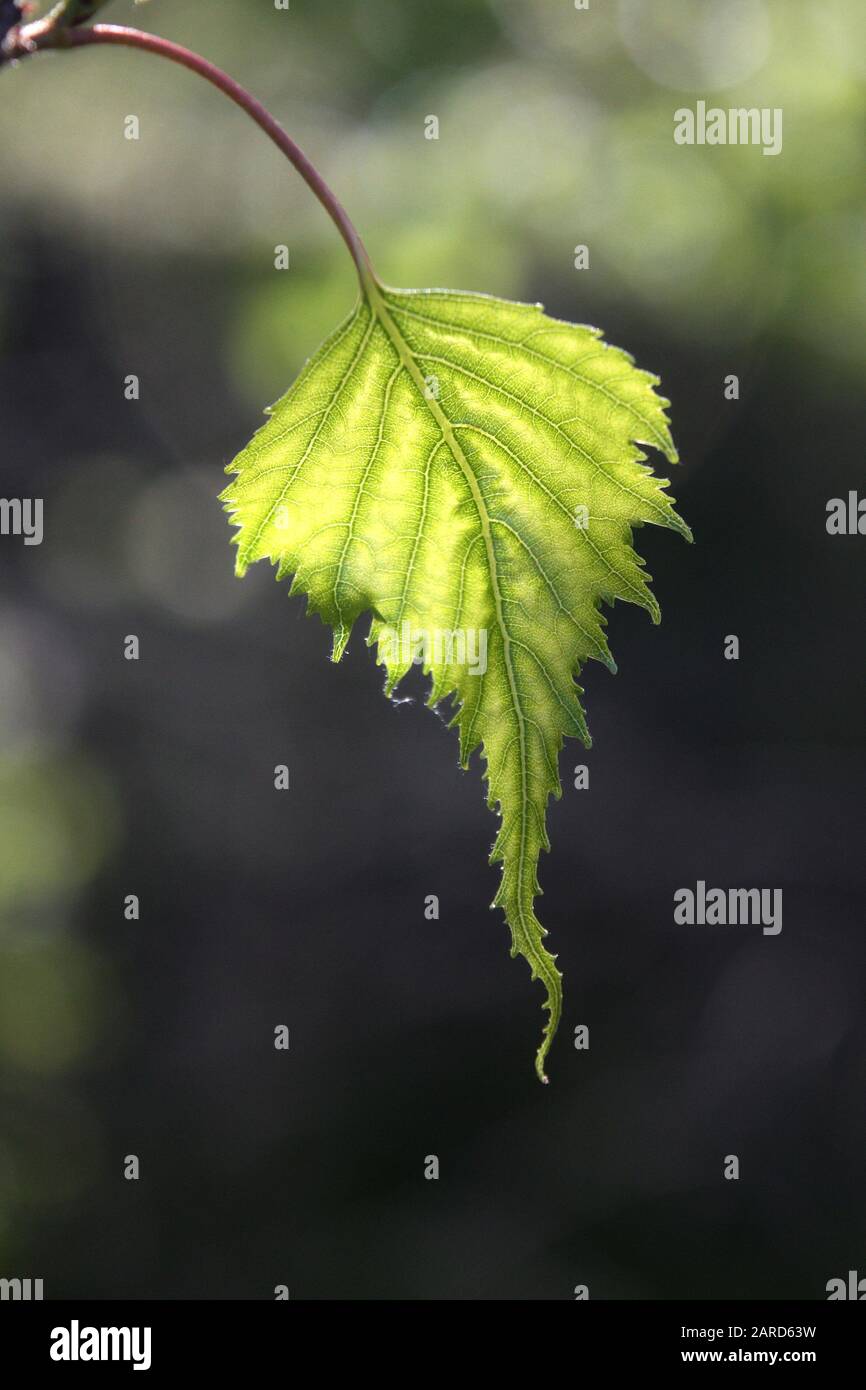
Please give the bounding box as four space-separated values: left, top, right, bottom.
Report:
222 282 689 1080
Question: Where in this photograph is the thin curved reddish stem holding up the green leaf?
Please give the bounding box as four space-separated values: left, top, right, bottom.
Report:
50 24 375 292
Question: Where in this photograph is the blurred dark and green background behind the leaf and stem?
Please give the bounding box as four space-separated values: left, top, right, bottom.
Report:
0 0 866 1300
